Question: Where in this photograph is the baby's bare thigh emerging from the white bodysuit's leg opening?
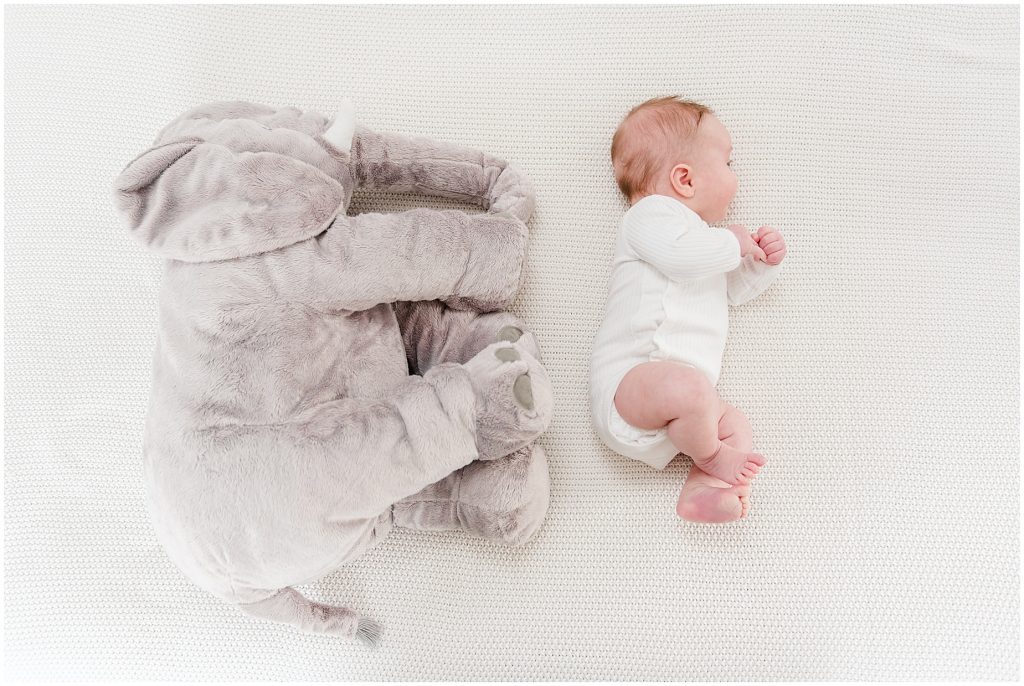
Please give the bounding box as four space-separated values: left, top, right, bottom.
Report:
614 360 720 429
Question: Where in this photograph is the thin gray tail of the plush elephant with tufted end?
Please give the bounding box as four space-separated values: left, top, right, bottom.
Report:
238 588 383 647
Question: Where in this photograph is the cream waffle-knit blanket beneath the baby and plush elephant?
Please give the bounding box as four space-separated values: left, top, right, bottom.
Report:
4 5 1020 680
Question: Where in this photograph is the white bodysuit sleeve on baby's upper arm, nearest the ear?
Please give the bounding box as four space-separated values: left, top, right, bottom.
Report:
623 196 741 282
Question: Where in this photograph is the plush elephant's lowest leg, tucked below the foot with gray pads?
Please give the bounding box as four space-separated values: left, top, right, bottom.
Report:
392 442 550 546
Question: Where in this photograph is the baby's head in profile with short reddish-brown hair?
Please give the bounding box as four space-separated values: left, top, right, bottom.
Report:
611 96 736 223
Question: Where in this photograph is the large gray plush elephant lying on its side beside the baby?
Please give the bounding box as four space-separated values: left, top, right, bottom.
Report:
114 102 553 643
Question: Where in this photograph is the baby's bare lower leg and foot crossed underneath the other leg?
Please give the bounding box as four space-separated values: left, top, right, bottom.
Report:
676 400 754 522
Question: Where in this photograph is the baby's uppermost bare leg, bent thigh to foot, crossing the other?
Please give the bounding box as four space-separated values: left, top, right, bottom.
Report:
614 361 765 484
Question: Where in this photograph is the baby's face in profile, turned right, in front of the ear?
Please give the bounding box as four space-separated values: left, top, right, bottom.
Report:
684 114 737 224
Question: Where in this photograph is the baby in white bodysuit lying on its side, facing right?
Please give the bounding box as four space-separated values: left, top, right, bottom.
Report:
590 97 785 522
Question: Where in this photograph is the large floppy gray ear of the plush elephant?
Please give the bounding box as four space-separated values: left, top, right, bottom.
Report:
114 137 345 262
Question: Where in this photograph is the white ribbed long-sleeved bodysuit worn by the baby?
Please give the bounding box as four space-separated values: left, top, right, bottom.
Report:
590 196 779 469
